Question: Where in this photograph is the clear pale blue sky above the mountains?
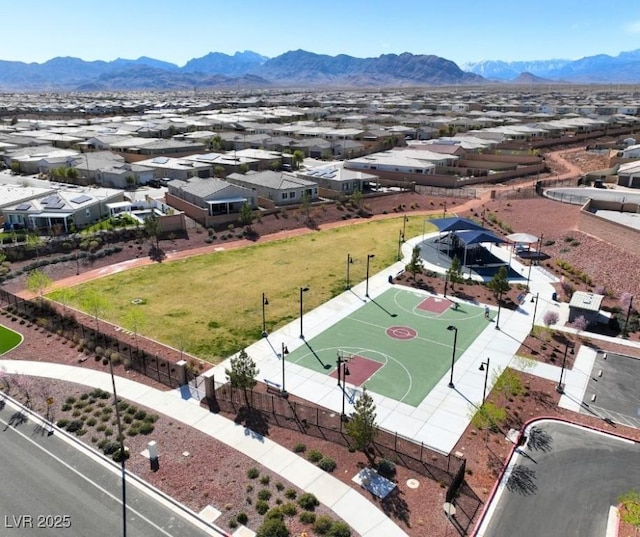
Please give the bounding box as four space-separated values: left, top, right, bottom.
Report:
7 0 640 66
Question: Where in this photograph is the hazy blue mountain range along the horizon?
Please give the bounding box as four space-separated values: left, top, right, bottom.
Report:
0 49 640 92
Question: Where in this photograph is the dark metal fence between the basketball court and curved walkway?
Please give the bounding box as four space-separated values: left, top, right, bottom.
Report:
209 383 463 486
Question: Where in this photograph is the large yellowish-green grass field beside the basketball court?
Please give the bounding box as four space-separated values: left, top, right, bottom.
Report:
48 215 434 362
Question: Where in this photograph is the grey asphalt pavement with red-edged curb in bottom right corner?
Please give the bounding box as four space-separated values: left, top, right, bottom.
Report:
478 422 640 537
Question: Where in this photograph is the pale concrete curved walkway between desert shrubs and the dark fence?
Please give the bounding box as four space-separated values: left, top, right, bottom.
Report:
0 360 407 537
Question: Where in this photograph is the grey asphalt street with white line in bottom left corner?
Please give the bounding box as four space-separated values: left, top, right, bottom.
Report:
0 405 218 537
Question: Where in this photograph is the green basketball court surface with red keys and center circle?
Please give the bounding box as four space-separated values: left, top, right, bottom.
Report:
287 288 489 406
